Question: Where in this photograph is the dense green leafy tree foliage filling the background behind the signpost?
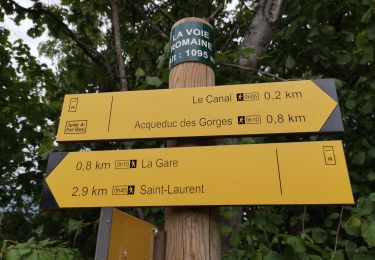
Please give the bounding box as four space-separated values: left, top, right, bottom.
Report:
0 0 375 259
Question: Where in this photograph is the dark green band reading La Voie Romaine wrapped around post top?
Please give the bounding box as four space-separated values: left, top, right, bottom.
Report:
169 22 216 69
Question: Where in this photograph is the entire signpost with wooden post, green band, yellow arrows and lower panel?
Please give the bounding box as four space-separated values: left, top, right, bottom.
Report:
40 17 354 259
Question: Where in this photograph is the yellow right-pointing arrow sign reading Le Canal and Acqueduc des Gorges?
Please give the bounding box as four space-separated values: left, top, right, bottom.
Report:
57 80 343 142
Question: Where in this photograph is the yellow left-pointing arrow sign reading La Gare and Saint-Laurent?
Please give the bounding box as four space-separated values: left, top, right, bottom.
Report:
41 141 353 208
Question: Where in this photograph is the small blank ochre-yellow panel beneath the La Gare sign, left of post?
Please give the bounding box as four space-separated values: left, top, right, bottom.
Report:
108 209 154 260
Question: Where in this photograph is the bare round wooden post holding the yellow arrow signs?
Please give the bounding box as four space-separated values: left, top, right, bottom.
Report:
165 17 220 260
